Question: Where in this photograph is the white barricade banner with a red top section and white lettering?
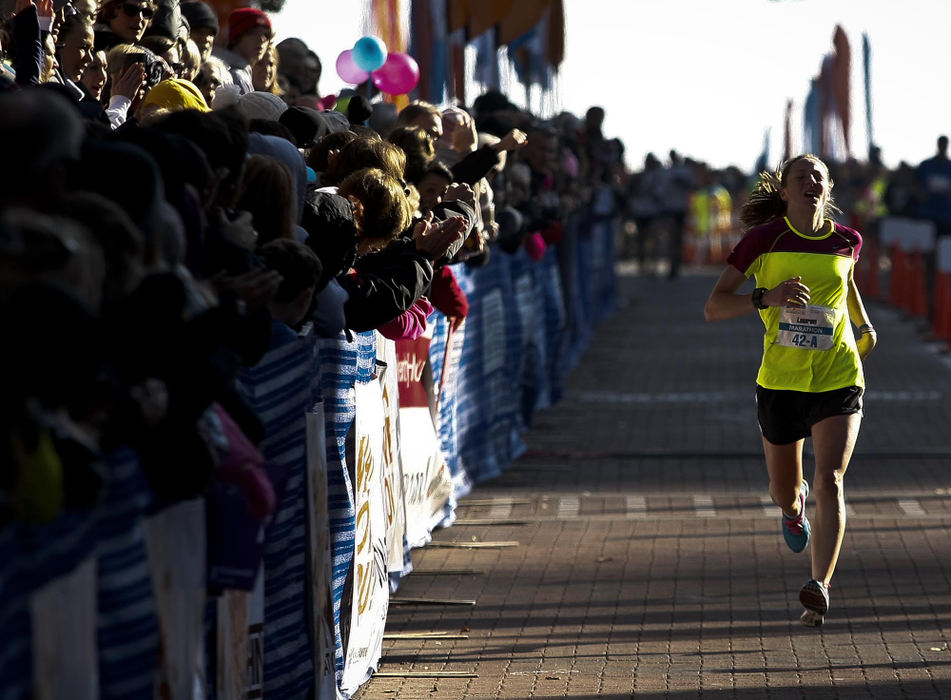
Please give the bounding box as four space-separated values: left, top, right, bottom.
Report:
396 324 452 547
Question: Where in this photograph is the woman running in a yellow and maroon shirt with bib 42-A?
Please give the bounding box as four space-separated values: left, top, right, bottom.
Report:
704 154 876 627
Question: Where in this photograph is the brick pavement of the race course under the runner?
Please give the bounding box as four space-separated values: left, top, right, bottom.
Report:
356 266 951 700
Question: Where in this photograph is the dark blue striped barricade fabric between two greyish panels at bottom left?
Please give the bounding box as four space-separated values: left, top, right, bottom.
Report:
96 448 159 700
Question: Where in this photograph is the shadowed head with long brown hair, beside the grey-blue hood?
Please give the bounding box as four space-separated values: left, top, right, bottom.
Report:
235 154 297 246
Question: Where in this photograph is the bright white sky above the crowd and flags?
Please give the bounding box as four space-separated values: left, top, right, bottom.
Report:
273 0 951 170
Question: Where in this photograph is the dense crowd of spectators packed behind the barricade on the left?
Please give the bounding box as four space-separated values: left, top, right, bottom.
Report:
0 0 623 536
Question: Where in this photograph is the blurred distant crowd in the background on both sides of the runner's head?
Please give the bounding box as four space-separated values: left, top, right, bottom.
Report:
617 136 951 286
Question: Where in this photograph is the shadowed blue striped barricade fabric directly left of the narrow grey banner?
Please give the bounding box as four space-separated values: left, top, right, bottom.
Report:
238 320 320 697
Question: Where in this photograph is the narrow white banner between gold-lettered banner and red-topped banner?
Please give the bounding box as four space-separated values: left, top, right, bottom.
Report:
377 336 412 576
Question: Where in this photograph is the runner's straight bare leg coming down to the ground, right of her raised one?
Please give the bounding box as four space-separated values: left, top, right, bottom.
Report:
812 413 862 585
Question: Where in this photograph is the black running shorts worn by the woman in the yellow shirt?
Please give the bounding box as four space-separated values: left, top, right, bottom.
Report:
756 386 865 445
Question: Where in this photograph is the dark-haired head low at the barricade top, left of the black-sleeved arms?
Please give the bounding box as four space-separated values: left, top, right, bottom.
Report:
257 239 323 327
